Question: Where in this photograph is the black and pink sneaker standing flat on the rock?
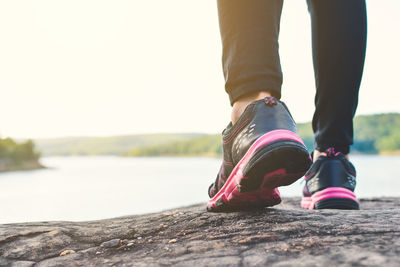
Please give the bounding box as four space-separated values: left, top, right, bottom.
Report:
301 148 359 210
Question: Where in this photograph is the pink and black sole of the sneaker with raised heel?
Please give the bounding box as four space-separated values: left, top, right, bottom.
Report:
207 130 311 212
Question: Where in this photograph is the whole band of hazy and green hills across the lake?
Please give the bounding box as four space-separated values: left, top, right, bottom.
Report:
35 113 400 156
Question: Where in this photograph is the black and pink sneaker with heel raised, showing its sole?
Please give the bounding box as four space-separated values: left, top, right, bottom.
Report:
207 97 311 211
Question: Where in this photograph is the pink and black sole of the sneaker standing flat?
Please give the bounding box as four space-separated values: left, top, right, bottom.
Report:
301 187 360 210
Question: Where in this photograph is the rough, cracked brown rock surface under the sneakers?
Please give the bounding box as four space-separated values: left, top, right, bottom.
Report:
0 198 400 267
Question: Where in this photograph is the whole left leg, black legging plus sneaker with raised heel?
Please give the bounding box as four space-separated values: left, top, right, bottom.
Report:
207 0 311 211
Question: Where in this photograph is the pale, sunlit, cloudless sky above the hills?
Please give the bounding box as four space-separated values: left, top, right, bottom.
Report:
0 0 400 138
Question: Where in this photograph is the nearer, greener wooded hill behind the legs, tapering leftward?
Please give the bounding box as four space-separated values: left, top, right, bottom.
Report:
128 113 400 156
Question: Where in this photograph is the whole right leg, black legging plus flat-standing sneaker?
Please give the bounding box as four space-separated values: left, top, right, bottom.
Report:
301 0 367 213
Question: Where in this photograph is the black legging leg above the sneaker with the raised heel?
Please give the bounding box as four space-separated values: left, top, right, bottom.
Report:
218 0 283 109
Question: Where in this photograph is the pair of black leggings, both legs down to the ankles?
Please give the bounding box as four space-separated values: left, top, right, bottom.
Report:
218 0 367 154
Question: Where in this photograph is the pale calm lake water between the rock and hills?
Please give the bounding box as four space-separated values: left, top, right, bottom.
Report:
0 155 400 223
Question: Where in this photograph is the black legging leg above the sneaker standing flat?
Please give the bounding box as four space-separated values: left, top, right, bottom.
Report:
307 0 367 156
